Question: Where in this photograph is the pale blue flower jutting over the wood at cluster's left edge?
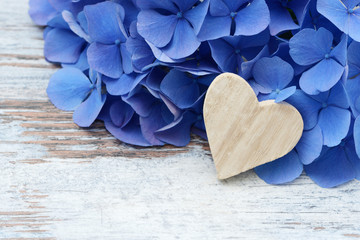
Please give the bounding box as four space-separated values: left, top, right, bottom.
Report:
46 68 107 127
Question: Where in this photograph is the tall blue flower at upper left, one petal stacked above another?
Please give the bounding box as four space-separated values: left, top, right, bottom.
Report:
84 1 133 78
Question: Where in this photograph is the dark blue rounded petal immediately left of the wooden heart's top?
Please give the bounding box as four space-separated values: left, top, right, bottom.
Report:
160 70 200 109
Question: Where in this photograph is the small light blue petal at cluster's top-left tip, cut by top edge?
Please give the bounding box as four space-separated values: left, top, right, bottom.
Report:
29 0 58 26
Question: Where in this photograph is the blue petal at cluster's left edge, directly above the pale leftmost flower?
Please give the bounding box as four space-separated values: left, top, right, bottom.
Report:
44 28 85 63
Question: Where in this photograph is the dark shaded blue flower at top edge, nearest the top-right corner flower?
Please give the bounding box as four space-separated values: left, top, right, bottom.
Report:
266 0 310 36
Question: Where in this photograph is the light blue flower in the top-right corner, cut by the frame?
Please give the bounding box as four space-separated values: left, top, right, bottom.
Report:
317 0 360 42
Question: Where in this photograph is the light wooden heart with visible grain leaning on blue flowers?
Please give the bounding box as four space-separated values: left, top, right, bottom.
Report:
204 73 304 179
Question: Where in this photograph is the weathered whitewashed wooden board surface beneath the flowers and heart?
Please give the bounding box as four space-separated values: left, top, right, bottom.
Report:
0 0 360 240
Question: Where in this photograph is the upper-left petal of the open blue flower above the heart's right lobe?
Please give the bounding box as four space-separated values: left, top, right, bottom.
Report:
289 28 333 66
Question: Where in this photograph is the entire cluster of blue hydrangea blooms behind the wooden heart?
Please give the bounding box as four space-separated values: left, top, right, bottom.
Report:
29 0 360 187
